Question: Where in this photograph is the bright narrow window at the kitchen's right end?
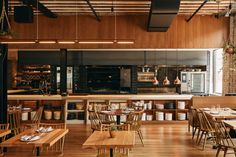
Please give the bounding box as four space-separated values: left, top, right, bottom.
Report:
213 49 223 94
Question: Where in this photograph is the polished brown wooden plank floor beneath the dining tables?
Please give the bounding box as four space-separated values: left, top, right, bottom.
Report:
1 124 234 157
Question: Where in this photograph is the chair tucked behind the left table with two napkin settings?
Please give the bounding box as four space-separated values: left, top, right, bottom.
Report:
39 123 66 155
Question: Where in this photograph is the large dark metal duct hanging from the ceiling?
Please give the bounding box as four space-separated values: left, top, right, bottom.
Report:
147 0 180 32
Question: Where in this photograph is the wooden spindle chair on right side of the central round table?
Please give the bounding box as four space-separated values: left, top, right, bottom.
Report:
125 109 144 146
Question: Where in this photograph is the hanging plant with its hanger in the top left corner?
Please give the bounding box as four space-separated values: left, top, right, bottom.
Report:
0 0 14 39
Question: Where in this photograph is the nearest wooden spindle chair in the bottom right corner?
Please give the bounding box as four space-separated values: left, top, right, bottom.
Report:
215 121 236 157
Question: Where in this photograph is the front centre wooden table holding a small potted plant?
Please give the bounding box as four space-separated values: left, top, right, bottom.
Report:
83 131 135 157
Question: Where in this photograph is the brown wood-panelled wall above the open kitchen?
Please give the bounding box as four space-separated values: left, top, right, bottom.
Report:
6 16 229 49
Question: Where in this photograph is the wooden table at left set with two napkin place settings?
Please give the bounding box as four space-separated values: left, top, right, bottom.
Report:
0 129 69 156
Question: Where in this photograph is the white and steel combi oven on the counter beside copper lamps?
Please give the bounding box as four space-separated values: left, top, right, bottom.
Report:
181 71 208 94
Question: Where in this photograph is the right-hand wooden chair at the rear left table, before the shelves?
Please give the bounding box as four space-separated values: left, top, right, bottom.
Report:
23 106 43 128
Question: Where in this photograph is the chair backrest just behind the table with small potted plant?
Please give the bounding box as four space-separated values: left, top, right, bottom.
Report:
101 124 130 131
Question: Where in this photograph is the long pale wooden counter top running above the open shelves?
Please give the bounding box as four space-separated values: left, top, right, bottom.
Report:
8 94 193 100
